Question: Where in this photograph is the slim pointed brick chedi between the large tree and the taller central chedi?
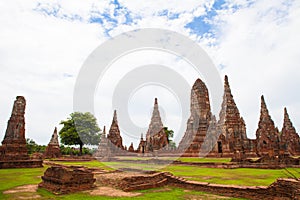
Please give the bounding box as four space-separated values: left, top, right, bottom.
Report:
107 110 124 149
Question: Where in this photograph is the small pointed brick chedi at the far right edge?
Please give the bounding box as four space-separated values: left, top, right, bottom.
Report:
280 108 300 156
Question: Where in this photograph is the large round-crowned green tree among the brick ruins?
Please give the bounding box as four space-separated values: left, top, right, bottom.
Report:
59 112 101 155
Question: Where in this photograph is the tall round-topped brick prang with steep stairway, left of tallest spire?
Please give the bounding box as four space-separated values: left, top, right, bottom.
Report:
179 79 212 157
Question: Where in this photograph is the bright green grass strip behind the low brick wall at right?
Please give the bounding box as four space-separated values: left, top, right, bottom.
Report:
162 165 300 186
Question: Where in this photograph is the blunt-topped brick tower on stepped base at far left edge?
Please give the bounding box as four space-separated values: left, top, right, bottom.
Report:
0 96 43 169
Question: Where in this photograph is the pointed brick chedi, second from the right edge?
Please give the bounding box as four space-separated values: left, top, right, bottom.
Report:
256 96 279 157
